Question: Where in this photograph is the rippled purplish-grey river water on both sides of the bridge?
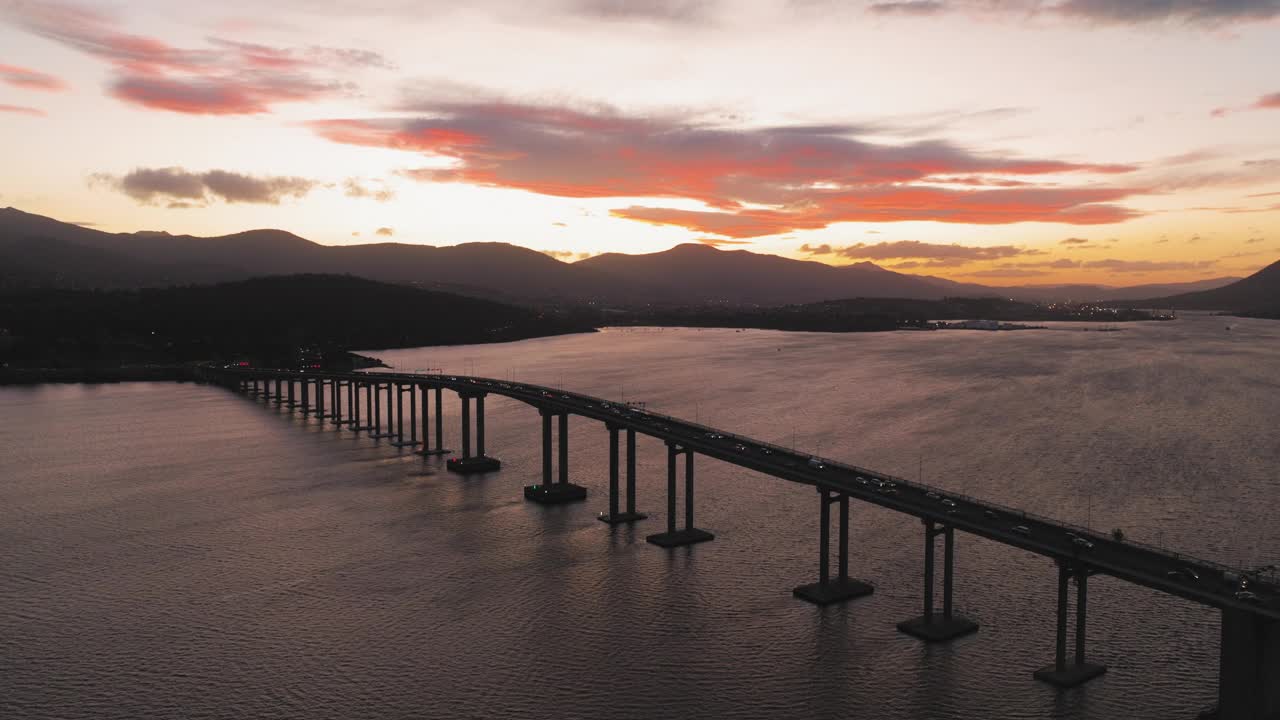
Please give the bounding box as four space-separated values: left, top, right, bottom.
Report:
0 315 1280 720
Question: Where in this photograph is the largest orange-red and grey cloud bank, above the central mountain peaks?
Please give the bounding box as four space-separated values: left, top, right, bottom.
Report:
311 102 1139 238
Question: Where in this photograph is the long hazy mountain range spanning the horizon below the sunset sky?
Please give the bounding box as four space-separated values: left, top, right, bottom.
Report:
0 208 1259 306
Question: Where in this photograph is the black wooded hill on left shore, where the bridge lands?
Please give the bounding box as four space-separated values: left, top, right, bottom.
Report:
0 270 593 368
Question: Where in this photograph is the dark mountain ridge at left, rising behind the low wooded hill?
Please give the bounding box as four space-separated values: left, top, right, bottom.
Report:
0 208 616 300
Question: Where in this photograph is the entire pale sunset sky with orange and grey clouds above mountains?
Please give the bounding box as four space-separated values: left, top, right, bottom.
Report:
0 0 1280 284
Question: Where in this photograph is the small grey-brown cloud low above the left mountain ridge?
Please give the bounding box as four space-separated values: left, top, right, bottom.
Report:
91 168 320 209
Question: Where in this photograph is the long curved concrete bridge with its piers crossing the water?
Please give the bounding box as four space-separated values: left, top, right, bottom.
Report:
197 366 1280 720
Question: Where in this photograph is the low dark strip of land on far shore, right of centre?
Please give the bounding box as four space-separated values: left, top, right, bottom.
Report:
600 297 1152 332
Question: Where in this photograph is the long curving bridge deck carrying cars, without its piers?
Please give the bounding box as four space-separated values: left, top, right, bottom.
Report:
345 372 1280 619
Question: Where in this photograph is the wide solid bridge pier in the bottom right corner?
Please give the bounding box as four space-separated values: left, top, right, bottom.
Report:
1201 609 1280 720
